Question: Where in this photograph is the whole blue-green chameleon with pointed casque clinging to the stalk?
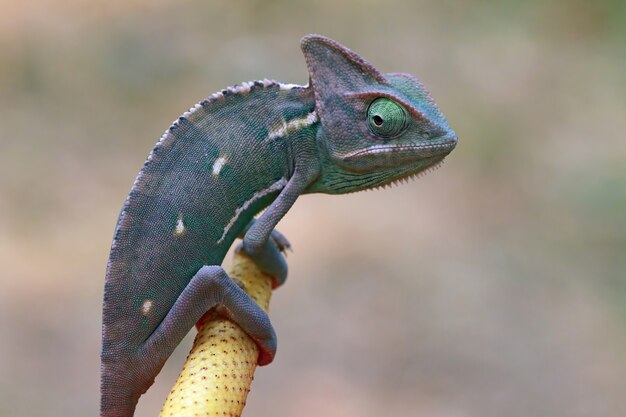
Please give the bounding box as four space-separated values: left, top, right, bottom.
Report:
100 35 457 417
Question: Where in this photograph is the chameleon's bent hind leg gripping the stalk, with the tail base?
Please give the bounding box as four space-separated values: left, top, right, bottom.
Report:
100 266 276 417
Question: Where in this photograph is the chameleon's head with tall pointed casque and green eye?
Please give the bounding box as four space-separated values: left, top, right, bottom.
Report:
301 35 457 194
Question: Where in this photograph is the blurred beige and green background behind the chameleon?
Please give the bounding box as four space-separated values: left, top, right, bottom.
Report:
0 0 626 417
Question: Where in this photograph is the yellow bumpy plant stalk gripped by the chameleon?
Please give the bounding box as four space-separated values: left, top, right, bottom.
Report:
159 250 272 417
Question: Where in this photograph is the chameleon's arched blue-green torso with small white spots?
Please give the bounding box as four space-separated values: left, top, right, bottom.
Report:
102 80 313 358
